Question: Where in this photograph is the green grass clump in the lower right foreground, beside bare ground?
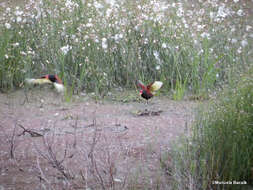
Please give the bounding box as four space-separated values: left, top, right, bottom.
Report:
168 69 253 189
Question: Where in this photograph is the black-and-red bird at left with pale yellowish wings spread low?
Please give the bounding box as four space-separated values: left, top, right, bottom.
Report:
25 75 64 93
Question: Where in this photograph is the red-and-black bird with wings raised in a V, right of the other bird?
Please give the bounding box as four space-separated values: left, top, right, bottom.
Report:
137 81 163 103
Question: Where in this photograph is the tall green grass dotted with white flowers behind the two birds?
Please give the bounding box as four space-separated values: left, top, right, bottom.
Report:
0 0 252 99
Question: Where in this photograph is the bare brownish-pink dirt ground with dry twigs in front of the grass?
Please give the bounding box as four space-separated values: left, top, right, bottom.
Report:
0 88 199 190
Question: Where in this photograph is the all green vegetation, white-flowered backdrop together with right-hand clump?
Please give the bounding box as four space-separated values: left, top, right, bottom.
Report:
0 0 253 189
